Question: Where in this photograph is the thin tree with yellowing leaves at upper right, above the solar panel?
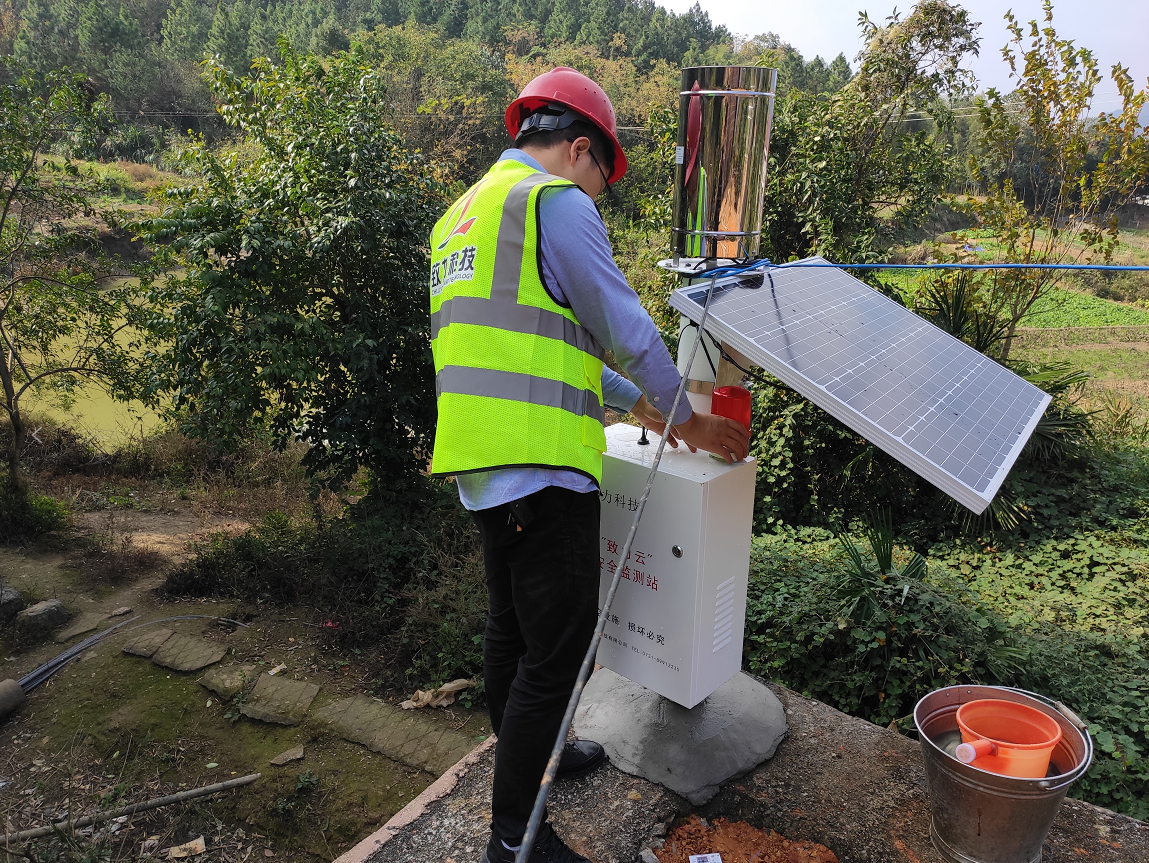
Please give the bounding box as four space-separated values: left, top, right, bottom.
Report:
958 0 1149 360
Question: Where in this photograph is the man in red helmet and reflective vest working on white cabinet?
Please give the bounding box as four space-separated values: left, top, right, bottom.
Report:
431 68 749 863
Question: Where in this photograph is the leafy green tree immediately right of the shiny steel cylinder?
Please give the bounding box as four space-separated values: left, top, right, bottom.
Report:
763 0 978 262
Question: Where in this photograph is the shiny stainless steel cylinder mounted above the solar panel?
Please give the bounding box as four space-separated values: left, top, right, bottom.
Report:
671 66 778 259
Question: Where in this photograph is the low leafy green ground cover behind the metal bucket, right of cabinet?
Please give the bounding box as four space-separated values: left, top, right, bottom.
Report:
745 524 1149 818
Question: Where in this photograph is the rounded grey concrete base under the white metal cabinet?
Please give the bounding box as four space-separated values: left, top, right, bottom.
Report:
575 669 786 806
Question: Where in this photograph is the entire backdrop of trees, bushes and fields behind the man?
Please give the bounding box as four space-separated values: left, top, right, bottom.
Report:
0 0 1149 850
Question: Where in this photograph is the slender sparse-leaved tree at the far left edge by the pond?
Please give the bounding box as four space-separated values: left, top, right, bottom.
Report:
0 59 146 503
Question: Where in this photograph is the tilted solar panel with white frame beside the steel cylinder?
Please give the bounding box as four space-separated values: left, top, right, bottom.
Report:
670 257 1050 513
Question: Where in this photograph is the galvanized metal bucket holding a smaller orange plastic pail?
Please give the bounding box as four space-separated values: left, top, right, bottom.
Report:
913 686 1093 863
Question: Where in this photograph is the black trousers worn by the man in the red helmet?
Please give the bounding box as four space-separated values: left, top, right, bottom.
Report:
472 486 599 845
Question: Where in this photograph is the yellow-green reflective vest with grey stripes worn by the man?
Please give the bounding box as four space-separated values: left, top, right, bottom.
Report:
431 160 607 484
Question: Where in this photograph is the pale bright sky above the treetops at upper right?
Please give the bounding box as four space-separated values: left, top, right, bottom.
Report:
662 0 1149 110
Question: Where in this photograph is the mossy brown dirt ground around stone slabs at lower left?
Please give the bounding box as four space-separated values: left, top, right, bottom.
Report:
0 494 489 863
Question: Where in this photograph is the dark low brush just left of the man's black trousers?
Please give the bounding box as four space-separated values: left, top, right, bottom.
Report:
164 480 486 688
